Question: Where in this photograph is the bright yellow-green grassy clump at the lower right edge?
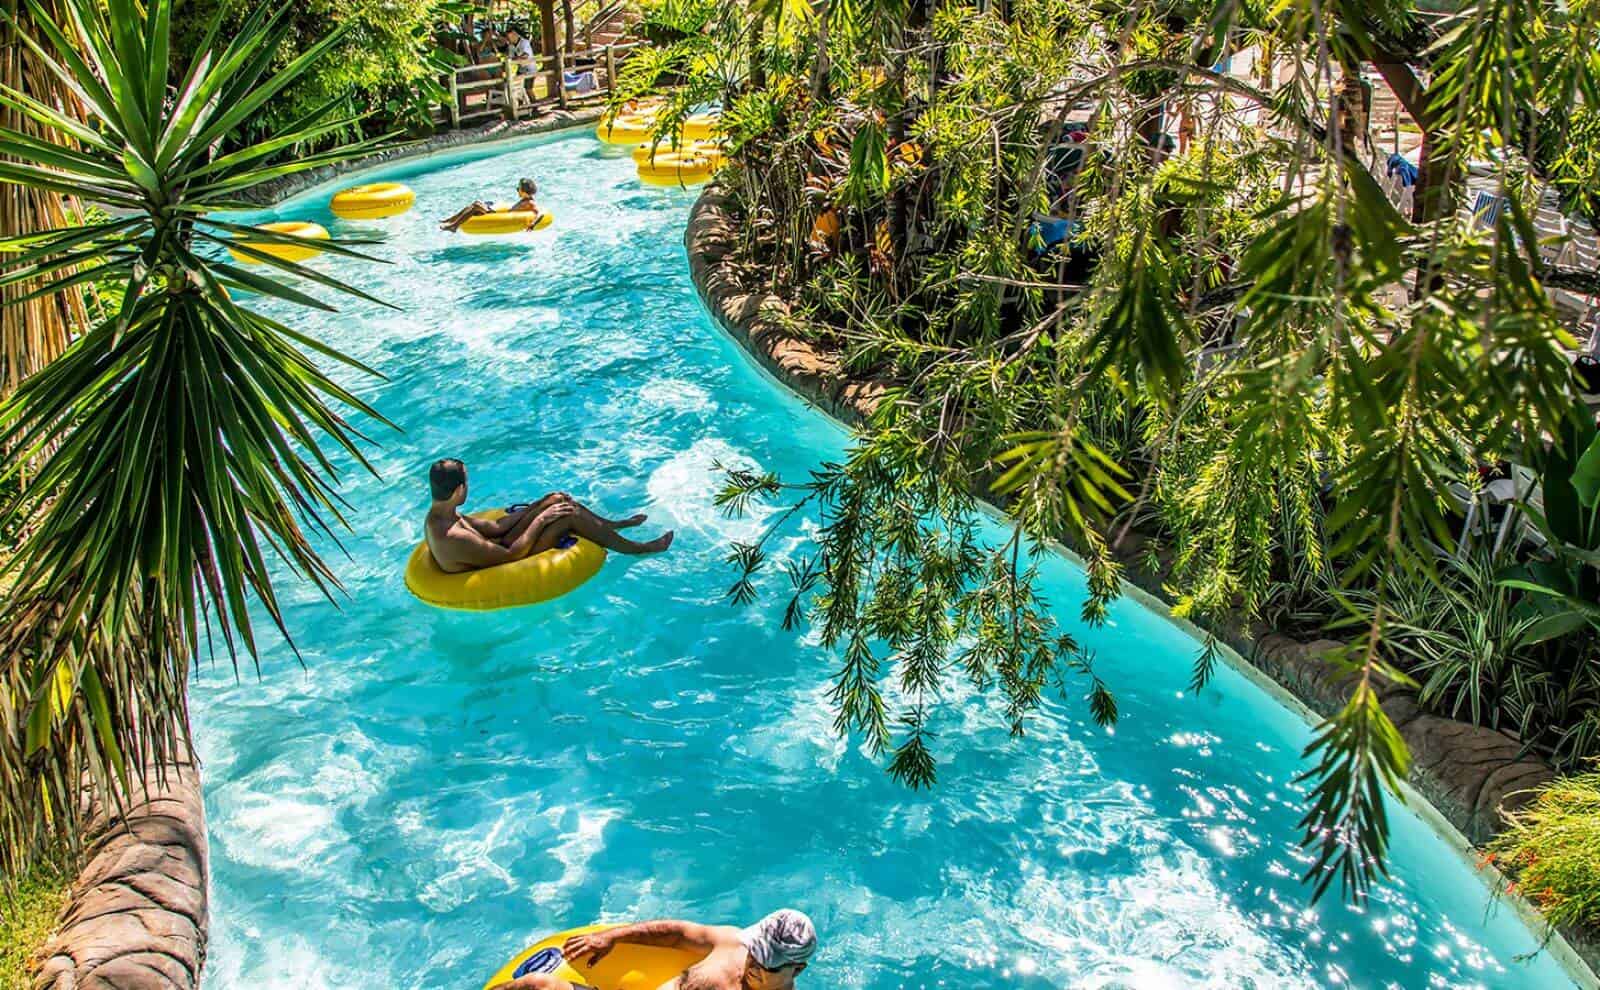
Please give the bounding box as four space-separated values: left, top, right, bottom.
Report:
1488 771 1600 931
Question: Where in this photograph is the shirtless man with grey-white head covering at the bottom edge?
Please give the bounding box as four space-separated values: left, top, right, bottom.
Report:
493 908 816 990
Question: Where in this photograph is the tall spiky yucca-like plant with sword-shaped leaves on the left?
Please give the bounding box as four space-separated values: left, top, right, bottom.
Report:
0 0 390 875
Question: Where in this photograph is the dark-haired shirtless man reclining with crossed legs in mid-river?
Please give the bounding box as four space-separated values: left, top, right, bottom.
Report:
422 457 672 574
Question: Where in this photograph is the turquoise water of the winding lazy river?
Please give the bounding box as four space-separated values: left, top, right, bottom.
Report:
194 136 1568 990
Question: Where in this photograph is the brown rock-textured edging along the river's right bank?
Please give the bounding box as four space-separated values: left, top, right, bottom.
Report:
683 184 1600 988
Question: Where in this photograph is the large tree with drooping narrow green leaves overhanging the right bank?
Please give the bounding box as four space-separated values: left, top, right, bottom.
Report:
630 0 1600 896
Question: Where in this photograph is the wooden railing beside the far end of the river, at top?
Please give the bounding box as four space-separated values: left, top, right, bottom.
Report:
446 42 642 128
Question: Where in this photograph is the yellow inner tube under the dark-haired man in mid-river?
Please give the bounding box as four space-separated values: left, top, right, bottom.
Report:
405 509 604 610
